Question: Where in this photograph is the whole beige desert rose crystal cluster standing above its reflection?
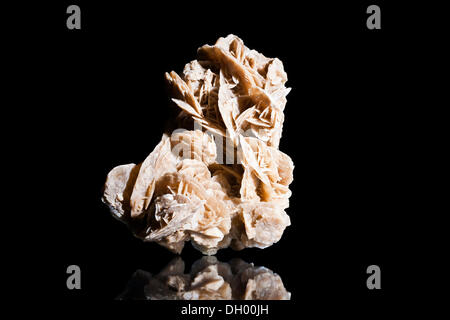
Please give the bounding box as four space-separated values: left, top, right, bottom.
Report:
102 35 294 255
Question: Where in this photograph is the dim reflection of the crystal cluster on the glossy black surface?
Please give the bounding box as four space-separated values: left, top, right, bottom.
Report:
118 257 291 300
